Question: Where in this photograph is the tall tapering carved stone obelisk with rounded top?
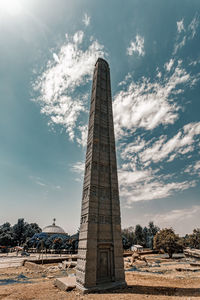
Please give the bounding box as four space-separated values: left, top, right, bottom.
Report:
76 58 125 292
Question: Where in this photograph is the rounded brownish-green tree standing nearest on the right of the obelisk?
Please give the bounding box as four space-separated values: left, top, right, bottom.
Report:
154 228 182 258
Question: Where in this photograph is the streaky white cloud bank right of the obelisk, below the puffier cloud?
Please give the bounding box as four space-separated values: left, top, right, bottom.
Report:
119 122 200 204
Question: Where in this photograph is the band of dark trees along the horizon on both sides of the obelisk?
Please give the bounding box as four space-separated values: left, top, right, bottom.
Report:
0 218 200 257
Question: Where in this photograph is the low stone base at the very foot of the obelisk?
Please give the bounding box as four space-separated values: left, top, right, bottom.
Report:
76 281 127 294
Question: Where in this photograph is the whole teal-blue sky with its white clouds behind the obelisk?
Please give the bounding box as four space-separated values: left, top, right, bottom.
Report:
0 0 200 234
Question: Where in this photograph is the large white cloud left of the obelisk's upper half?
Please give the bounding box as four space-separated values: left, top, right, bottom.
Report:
34 31 104 144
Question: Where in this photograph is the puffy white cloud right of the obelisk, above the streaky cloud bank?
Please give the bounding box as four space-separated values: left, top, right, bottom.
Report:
113 61 194 137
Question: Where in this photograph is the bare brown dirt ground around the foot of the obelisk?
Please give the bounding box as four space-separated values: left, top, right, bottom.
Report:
0 256 200 300
